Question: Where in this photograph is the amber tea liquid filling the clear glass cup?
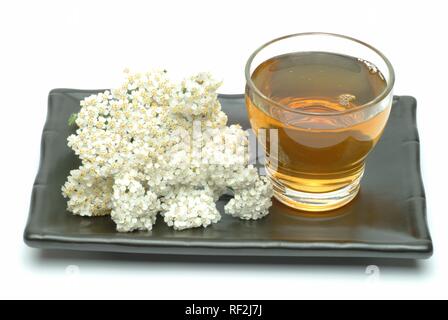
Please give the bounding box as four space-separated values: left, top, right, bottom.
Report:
246 52 390 211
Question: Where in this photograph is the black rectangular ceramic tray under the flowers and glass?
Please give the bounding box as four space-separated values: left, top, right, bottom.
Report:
25 89 432 259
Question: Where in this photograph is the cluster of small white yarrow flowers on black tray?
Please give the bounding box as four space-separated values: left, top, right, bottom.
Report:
62 70 272 232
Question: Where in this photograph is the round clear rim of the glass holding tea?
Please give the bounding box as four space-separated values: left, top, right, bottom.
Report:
245 32 395 116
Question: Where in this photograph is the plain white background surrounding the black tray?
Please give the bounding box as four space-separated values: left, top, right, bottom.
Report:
0 0 448 299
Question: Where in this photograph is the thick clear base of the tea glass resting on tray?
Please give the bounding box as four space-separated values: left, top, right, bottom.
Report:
268 173 362 212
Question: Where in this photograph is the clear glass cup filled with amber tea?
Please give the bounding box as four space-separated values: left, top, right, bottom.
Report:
245 33 394 211
